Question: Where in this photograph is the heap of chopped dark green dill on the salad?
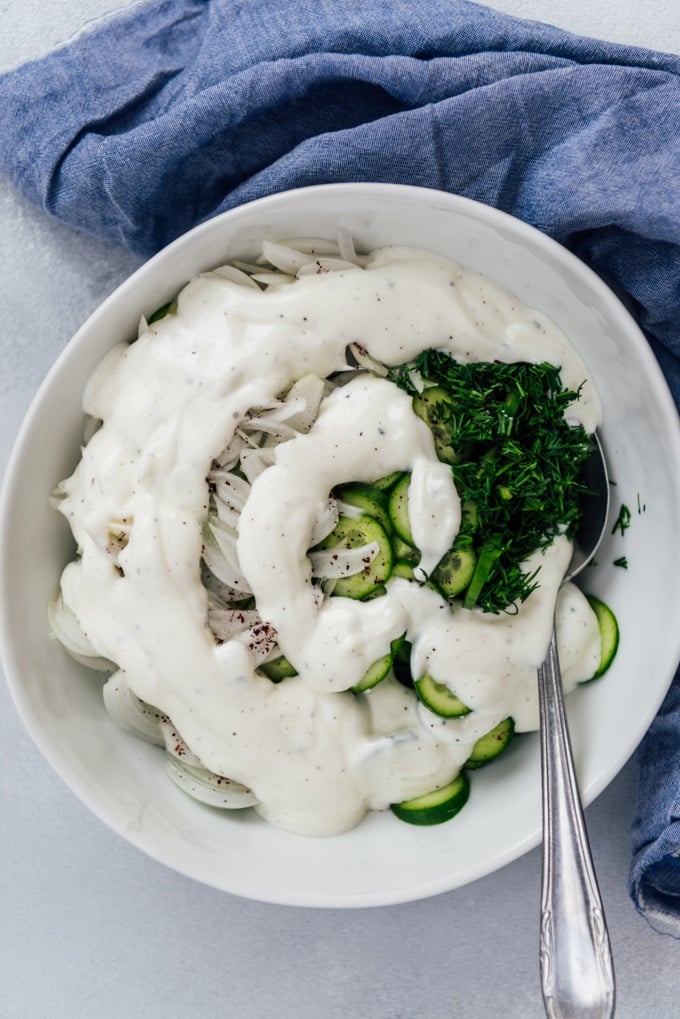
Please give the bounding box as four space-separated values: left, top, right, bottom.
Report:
390 350 592 612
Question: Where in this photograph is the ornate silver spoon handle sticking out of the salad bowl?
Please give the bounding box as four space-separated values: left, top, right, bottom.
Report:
538 630 615 1019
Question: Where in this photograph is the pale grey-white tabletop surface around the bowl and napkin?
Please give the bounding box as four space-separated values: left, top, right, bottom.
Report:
0 0 680 1019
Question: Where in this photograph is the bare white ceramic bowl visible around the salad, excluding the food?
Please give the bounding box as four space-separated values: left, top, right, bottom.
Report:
0 184 680 907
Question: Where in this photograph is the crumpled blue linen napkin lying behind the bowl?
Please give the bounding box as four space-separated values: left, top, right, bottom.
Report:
0 0 680 936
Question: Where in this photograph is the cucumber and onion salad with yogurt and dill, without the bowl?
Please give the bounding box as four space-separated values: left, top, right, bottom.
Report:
50 231 616 836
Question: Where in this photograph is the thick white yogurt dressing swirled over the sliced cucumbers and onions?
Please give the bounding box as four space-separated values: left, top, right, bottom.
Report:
55 248 601 835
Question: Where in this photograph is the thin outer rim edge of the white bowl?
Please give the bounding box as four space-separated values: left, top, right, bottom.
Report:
0 182 680 908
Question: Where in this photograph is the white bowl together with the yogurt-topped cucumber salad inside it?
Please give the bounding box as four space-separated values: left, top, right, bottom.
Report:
0 184 680 907
